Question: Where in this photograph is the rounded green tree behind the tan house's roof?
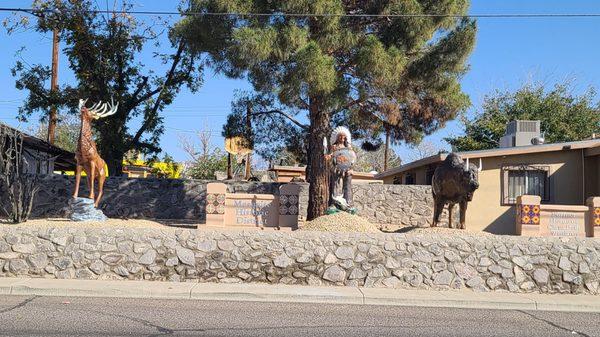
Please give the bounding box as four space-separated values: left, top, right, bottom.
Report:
446 83 600 151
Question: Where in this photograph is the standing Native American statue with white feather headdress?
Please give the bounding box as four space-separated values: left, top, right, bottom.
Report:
325 126 356 213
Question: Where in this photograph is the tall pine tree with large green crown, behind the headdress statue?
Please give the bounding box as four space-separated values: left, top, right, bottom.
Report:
176 0 476 219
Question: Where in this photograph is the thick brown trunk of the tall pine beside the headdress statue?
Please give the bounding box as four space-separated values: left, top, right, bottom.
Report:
307 98 330 220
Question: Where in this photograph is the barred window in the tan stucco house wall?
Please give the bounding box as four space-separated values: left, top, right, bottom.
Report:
502 165 550 205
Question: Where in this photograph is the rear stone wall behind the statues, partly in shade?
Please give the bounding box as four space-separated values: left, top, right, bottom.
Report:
21 175 446 226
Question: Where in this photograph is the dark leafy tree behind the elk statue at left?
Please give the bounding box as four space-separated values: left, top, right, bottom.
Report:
8 0 201 172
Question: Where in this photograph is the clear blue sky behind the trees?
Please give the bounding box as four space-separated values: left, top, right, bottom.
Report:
0 0 600 164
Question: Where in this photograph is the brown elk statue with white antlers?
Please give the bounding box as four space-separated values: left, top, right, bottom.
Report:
73 99 119 207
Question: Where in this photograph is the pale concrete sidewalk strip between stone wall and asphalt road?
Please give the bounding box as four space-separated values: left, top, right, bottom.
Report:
0 278 600 312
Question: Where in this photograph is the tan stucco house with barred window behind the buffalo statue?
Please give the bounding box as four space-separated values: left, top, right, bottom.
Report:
375 121 600 234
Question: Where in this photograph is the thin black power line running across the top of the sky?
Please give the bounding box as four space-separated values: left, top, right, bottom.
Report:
0 7 600 19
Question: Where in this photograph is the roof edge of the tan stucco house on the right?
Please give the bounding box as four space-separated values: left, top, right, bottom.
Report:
375 139 600 179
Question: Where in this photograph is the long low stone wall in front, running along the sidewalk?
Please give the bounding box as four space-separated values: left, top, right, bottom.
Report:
0 226 600 294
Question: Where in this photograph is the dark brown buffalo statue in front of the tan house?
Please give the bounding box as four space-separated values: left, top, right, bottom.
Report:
431 153 481 229
